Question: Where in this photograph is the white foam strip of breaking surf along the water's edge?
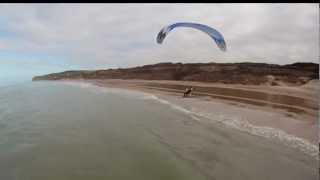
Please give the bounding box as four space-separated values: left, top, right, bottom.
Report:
143 95 319 158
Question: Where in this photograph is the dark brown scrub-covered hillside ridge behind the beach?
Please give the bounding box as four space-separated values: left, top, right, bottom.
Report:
32 62 319 85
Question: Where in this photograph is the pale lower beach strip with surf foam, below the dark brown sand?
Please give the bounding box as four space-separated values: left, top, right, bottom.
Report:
54 79 318 156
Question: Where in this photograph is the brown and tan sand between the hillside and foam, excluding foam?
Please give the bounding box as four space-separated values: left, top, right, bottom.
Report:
74 79 318 144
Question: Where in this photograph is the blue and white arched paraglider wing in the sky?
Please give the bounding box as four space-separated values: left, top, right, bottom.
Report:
157 23 227 51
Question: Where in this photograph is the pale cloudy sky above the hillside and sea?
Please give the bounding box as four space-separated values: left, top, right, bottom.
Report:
0 4 319 78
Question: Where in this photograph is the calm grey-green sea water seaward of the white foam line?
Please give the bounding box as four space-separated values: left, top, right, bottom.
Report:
0 82 318 180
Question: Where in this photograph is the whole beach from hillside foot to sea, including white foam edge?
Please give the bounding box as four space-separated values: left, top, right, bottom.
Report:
61 79 318 155
